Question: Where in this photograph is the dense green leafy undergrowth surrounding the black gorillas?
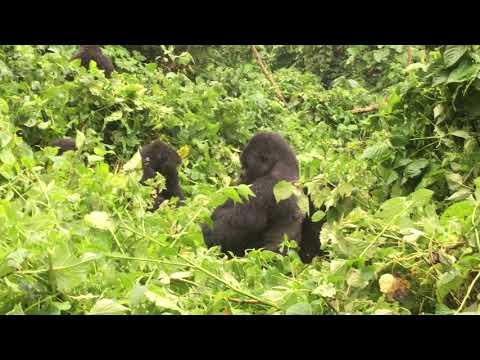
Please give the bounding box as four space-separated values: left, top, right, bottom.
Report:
0 46 480 314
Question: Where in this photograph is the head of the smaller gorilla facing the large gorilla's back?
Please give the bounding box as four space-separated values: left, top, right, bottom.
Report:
140 141 182 184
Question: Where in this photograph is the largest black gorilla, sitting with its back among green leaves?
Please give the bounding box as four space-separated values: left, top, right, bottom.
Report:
202 132 304 256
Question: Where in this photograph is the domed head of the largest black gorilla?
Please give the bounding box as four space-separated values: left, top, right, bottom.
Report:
240 132 299 184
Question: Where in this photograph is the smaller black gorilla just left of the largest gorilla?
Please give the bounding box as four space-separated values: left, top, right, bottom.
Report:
140 140 185 210
